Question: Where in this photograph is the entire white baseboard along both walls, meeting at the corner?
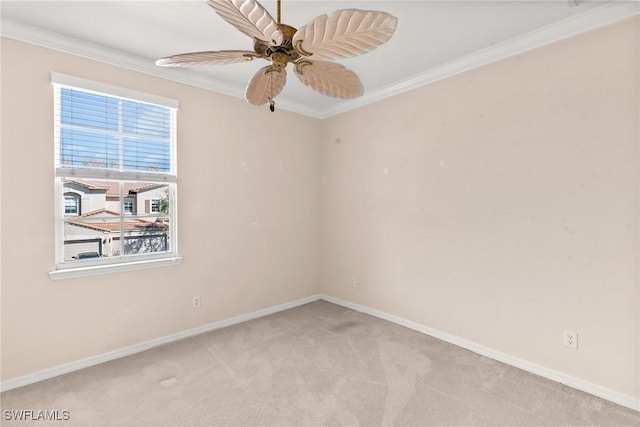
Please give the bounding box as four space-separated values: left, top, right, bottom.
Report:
0 294 640 411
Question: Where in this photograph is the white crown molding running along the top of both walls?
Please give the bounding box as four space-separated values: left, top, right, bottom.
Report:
0 0 640 119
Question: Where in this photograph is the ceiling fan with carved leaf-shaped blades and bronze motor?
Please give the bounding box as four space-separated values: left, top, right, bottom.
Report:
156 0 398 111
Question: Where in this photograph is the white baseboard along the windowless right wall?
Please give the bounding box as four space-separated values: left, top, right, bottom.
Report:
320 294 640 411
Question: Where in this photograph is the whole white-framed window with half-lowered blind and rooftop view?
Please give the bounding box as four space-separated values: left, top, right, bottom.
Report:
51 73 179 278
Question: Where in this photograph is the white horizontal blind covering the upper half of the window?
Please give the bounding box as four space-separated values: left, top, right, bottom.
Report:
54 76 176 181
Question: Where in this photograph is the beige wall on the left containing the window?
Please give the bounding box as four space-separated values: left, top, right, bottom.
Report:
2 40 321 379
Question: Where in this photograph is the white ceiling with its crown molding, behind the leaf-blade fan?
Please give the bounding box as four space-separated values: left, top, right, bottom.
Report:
0 0 639 117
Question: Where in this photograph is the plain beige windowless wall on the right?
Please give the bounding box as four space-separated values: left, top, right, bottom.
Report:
321 15 640 398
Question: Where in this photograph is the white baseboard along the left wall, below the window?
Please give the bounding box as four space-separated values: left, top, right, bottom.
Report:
0 295 320 391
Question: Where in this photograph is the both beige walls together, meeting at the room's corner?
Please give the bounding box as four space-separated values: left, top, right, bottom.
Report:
1 19 640 397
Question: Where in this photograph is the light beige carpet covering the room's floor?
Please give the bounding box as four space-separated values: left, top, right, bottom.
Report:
1 301 640 427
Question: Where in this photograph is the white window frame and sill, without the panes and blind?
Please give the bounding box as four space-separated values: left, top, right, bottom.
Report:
49 72 182 280
